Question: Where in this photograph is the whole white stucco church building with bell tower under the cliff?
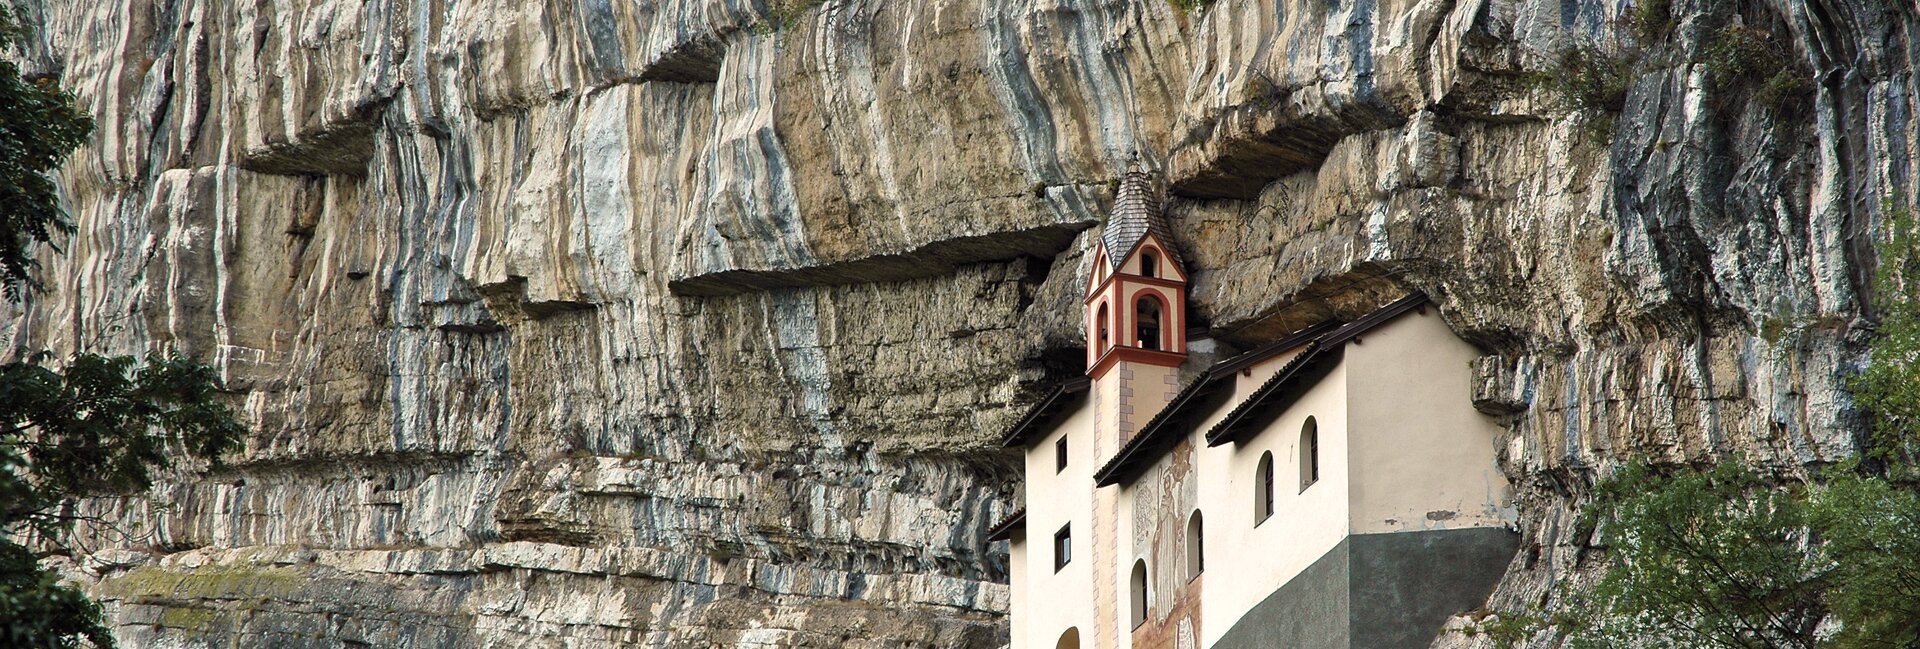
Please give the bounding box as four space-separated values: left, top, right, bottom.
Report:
993 173 1517 649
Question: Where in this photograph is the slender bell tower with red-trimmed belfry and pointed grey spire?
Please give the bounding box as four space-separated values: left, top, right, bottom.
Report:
1085 169 1187 449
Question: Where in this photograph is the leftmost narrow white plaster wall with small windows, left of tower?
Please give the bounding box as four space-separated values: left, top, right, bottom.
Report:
1010 403 1098 649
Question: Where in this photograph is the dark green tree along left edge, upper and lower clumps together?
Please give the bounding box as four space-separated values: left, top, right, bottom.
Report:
0 6 244 649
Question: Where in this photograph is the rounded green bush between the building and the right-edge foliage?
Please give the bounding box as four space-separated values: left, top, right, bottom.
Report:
1569 463 1824 649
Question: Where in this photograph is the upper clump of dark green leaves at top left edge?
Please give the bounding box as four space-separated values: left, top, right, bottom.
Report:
0 6 94 300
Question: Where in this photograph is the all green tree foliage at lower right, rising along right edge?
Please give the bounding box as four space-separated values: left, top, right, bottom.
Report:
1480 202 1920 649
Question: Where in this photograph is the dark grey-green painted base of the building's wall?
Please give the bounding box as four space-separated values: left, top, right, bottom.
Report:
1212 528 1519 649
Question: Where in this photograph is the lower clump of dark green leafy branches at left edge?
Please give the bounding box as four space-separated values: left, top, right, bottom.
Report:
0 355 244 647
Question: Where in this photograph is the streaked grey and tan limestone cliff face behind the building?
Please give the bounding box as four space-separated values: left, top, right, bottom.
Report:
0 0 1920 647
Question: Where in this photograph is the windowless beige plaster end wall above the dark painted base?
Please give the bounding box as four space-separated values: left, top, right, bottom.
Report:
1344 307 1515 534
